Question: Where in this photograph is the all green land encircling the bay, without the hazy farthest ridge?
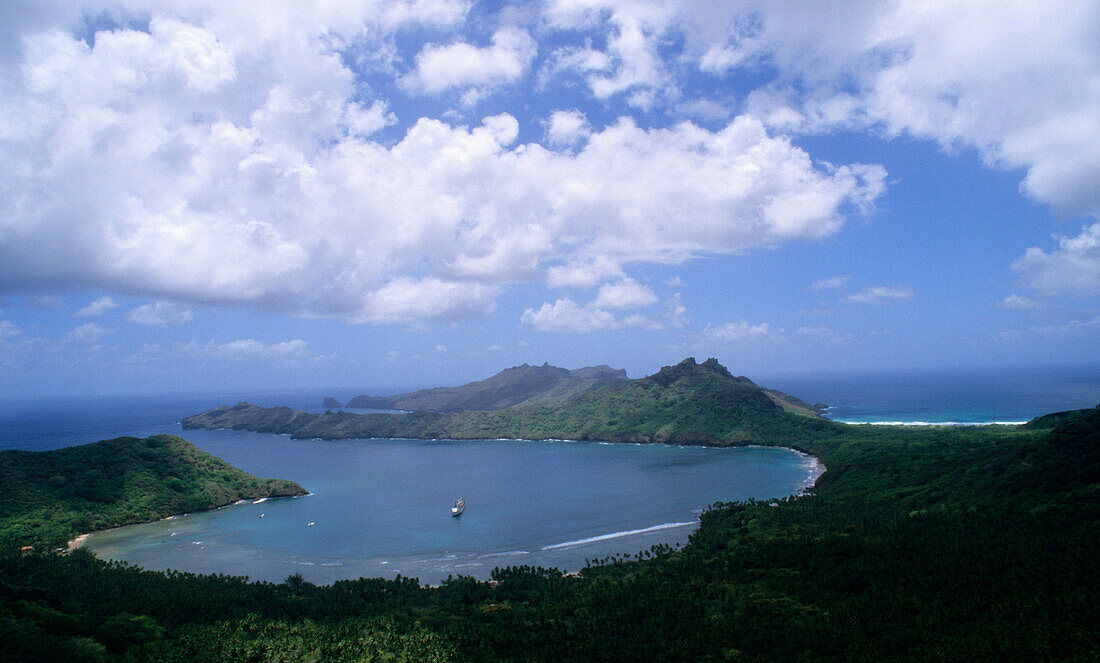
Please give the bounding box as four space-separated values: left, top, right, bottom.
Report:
0 371 1100 663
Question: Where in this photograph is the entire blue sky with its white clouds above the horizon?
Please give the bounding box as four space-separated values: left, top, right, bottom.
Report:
0 0 1100 396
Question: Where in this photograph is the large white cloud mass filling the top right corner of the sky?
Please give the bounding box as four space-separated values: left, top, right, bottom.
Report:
546 0 1100 216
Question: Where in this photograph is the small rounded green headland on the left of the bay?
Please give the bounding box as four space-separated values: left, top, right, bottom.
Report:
0 435 306 548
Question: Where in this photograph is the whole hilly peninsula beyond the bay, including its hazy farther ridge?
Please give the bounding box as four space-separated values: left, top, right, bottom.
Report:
189 357 837 445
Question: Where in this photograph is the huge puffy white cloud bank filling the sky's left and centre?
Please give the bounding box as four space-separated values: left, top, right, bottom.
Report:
0 2 884 323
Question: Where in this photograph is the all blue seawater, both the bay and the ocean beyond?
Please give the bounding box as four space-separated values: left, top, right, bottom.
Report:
0 367 1100 584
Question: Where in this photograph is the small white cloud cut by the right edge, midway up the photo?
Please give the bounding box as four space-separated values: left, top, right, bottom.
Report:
1012 223 1100 297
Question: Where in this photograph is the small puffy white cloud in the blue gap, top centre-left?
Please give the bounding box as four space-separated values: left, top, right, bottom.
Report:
403 27 538 93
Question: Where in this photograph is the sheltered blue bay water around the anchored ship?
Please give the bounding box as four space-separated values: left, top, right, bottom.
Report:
86 431 820 583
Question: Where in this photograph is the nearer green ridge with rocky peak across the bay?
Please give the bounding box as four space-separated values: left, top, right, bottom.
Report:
189 358 839 445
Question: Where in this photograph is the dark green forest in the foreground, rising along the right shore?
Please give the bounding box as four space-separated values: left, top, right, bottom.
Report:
0 383 1100 663
